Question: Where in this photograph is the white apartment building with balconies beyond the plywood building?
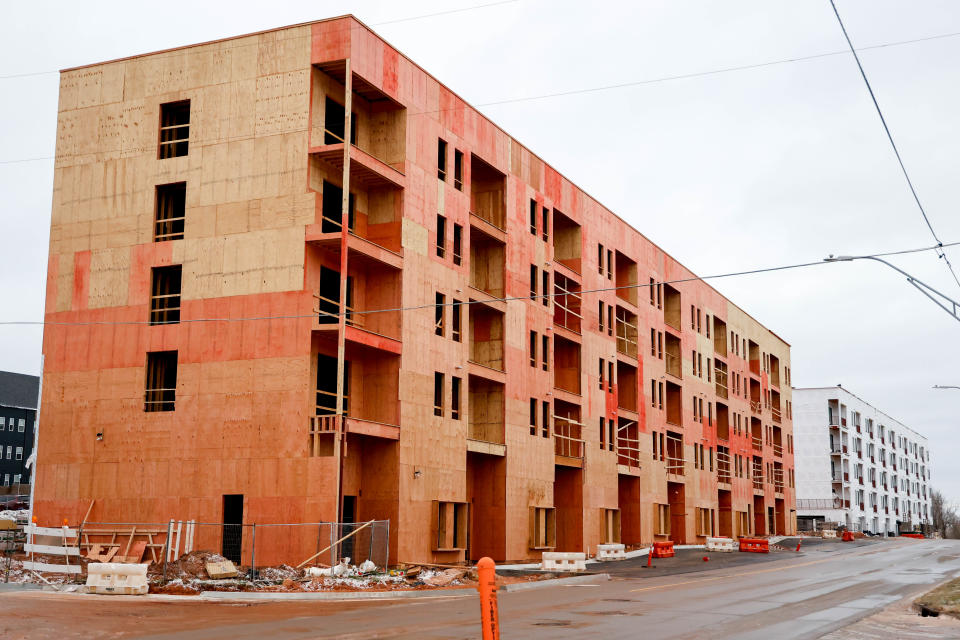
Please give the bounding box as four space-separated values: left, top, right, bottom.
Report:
793 385 930 535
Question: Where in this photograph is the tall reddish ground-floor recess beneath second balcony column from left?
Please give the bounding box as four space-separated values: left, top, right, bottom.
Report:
467 451 507 562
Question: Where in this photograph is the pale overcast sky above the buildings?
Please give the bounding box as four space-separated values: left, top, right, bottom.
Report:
0 0 960 502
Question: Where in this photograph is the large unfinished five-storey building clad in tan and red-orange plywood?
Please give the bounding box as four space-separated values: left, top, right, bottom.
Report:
36 16 795 562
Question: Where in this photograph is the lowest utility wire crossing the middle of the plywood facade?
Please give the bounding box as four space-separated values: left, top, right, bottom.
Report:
0 241 960 326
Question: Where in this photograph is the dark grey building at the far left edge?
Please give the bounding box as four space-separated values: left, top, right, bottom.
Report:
0 371 40 493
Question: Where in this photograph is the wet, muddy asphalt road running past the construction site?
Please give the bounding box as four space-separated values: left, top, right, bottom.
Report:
0 540 960 640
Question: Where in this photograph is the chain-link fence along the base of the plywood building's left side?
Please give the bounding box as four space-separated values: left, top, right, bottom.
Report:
78 520 390 576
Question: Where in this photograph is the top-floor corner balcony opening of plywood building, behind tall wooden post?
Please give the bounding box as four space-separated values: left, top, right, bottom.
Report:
311 66 407 171
